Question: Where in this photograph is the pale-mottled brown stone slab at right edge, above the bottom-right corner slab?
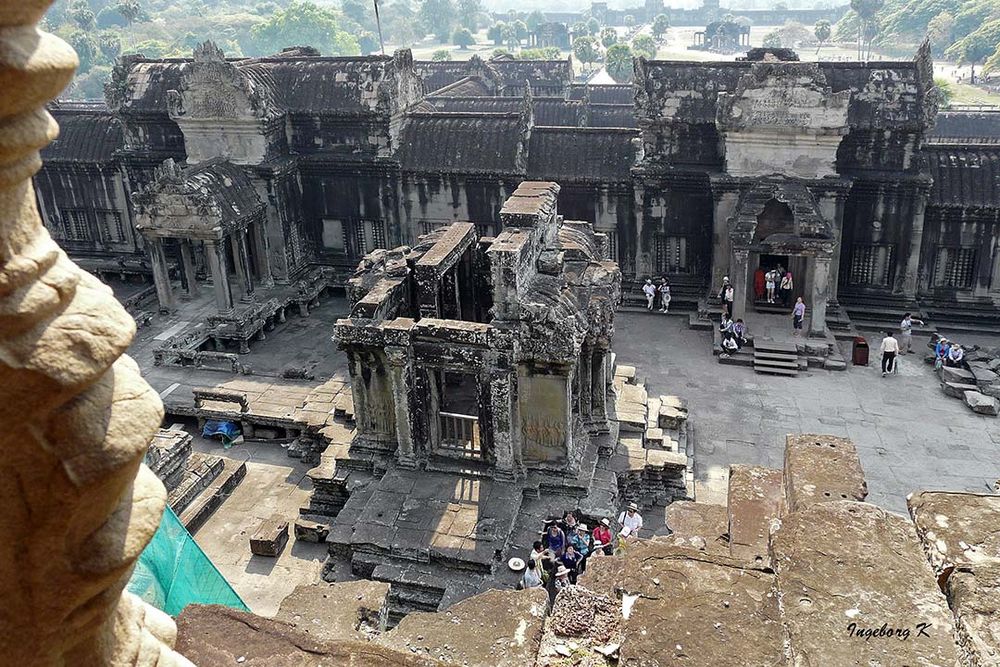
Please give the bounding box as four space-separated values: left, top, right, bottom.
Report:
906 491 1000 581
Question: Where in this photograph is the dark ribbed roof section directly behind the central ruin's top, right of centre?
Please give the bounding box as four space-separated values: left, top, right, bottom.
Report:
528 127 639 183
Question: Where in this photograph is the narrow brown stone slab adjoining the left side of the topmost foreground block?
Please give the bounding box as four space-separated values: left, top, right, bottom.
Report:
728 465 785 565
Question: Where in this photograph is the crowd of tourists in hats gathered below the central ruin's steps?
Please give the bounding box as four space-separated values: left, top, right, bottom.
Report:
518 503 642 597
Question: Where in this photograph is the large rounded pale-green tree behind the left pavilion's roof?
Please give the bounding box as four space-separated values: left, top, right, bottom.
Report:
250 0 361 56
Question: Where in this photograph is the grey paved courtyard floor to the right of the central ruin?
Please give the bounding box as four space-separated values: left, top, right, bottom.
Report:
613 312 1000 513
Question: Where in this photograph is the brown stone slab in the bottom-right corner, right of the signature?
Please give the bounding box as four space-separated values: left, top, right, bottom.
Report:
946 562 1000 665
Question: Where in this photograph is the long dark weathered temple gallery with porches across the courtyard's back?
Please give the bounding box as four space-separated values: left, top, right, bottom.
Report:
35 43 1000 333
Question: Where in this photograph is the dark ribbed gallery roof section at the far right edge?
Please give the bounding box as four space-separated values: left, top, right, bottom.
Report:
924 144 1000 208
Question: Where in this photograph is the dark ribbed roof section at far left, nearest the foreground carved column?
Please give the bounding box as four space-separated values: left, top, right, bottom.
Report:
42 107 123 162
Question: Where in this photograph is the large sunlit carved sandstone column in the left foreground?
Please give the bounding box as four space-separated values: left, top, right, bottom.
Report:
0 0 191 667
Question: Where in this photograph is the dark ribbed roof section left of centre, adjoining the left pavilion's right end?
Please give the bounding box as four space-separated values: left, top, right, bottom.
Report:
399 113 521 175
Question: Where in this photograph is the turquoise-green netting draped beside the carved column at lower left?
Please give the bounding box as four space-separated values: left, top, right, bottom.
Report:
128 506 250 616
